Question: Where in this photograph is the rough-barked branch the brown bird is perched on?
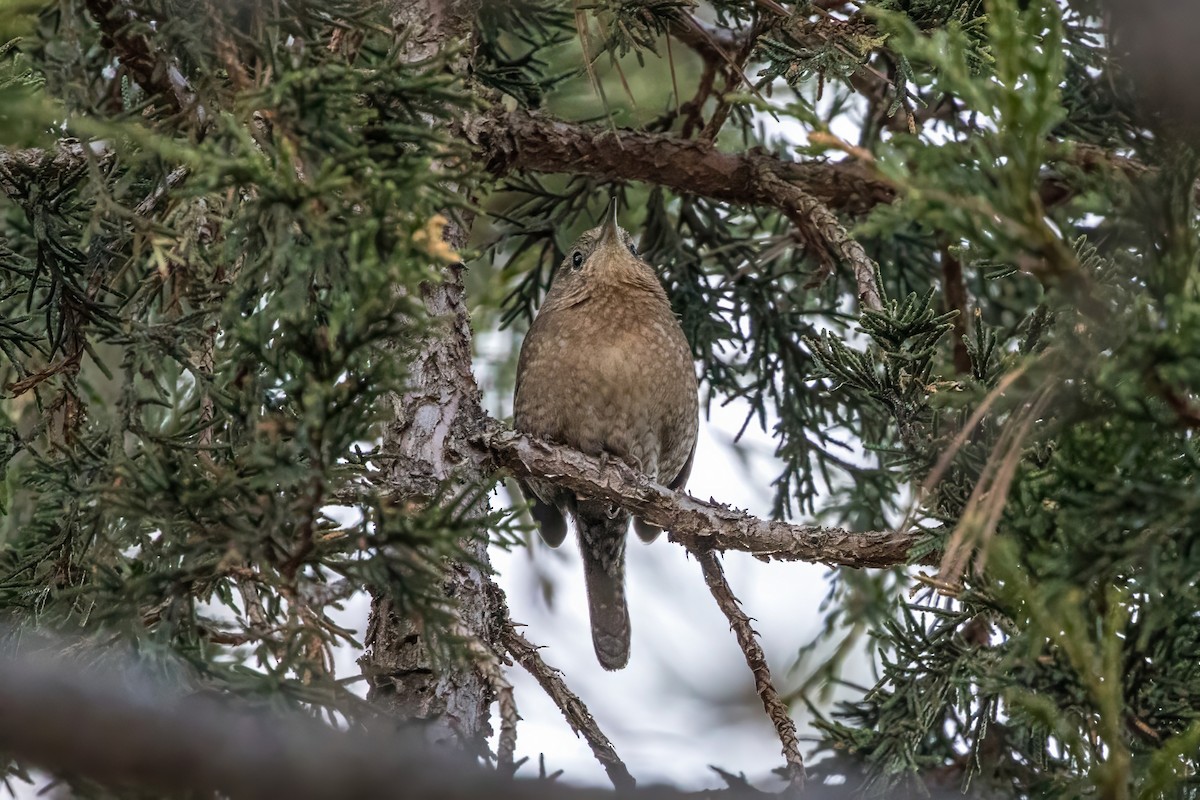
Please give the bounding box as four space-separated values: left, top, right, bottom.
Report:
479 420 921 567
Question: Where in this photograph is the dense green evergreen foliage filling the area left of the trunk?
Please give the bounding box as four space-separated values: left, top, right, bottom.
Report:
0 2 494 762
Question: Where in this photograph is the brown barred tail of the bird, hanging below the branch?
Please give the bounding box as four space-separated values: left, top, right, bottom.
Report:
575 500 630 669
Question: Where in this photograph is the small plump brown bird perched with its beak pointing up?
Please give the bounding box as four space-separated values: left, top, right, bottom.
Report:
514 200 698 669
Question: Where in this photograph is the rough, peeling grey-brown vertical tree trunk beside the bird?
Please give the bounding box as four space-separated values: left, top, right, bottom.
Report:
359 0 497 753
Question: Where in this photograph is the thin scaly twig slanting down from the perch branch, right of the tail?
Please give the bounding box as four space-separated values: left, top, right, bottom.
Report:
691 549 804 794
